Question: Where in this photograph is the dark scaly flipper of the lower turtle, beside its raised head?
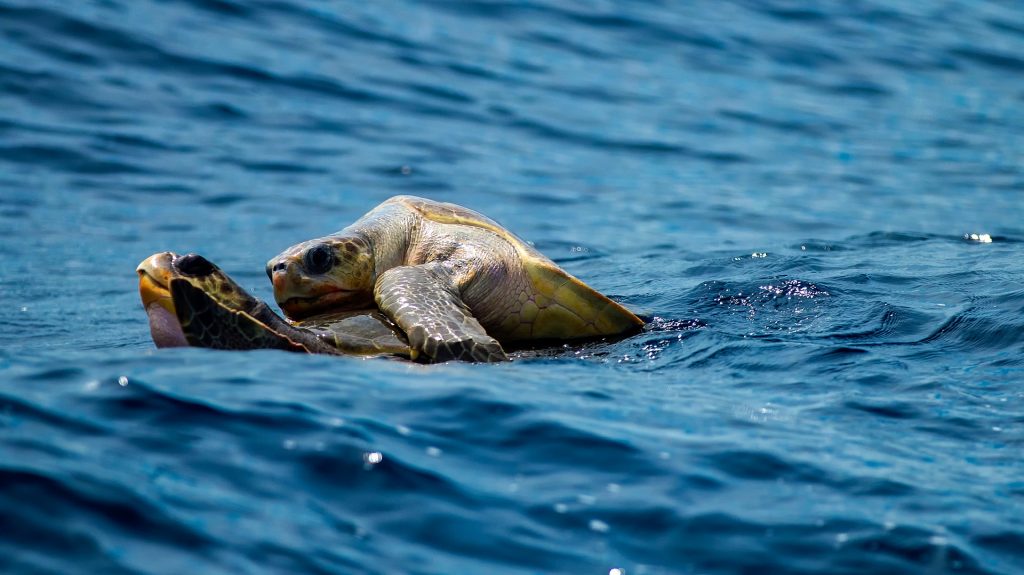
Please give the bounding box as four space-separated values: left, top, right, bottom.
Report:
170 279 337 353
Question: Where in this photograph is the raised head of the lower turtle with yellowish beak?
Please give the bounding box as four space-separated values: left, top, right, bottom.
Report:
135 252 259 347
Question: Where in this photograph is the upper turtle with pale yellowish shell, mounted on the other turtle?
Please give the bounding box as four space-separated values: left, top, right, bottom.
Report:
266 195 643 361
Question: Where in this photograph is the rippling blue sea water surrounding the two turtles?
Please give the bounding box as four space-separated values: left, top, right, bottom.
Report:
0 0 1024 575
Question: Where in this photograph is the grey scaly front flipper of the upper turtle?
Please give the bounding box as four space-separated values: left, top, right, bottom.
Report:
374 264 508 361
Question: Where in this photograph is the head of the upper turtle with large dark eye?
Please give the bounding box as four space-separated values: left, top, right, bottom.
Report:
266 234 377 319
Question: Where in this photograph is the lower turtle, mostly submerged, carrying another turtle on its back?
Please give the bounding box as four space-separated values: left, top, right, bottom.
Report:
137 252 417 358
